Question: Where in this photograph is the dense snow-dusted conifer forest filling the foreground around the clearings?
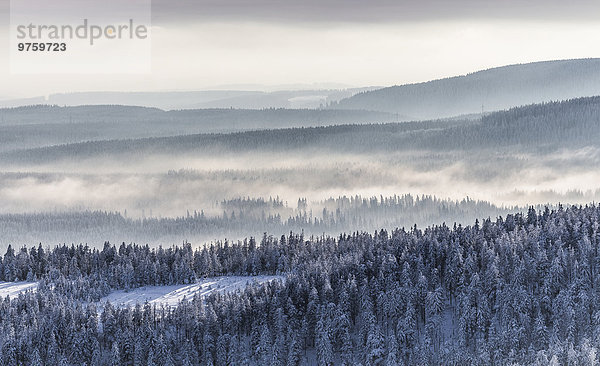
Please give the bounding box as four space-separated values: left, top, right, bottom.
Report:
0 205 600 365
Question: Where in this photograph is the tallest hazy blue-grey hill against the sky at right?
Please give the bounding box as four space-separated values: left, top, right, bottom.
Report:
332 59 600 119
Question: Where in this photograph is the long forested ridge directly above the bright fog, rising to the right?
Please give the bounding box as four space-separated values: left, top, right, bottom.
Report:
7 97 600 162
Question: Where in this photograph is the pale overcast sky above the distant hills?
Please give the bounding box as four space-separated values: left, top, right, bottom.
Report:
0 0 600 99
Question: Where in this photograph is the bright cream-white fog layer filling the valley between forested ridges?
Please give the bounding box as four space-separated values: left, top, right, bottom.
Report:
0 147 600 217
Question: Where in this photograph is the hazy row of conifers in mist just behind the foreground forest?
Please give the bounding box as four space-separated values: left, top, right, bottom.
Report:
0 193 511 250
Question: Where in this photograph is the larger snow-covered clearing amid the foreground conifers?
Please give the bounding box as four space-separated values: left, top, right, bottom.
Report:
100 276 285 307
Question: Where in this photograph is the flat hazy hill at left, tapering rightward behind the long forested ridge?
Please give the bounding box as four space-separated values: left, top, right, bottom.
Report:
0 105 397 152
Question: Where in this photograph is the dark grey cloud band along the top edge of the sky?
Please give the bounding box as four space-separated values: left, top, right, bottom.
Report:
152 0 600 24
